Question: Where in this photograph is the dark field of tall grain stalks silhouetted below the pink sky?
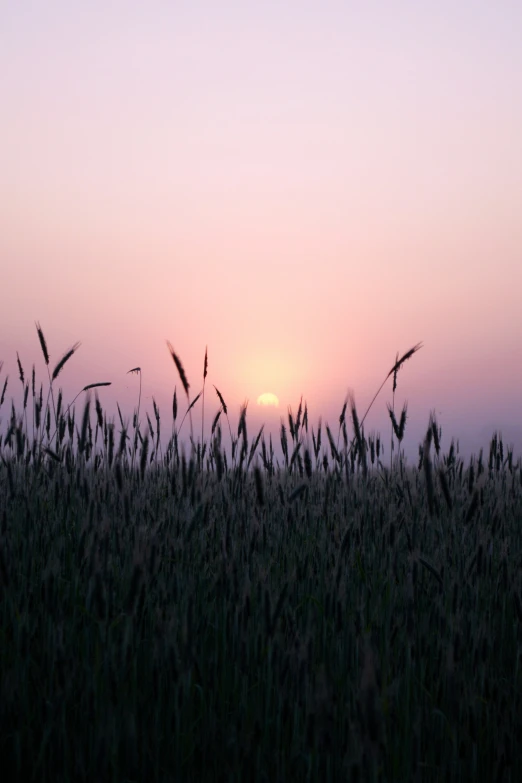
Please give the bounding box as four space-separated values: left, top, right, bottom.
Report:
0 334 522 783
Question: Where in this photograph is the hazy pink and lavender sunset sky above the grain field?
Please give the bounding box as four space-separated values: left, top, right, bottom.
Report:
0 0 522 462
